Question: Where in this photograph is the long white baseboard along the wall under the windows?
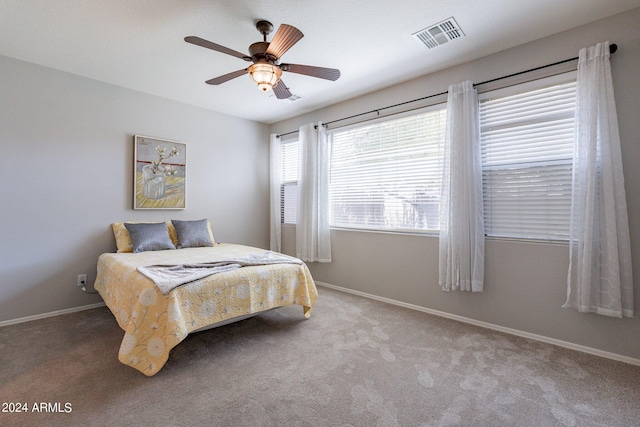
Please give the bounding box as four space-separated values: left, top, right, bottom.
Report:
316 281 640 366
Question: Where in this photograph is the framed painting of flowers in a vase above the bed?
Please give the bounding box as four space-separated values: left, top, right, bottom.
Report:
133 135 187 209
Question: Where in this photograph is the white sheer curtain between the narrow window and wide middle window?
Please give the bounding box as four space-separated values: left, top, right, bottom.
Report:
296 123 331 262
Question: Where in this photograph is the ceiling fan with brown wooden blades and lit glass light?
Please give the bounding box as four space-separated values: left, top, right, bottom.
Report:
184 21 340 99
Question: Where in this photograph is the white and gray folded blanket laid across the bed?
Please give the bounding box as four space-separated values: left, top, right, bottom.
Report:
138 251 302 295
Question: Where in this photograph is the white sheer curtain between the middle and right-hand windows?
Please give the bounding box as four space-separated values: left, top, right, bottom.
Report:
439 81 484 292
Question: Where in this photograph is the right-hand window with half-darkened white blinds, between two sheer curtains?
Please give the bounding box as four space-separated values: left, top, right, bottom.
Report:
480 76 576 240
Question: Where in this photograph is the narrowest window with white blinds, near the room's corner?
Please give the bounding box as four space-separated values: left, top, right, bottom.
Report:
280 140 300 224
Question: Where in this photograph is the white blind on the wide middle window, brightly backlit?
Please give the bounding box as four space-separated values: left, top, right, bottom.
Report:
329 106 446 231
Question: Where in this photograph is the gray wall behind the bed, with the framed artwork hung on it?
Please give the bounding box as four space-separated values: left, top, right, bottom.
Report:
0 56 269 321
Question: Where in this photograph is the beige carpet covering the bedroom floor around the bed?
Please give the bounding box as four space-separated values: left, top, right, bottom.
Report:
0 288 640 427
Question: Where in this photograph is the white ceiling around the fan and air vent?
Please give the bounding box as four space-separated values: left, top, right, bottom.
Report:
0 0 640 123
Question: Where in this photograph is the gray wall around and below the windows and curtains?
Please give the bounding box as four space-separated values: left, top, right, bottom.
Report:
271 9 640 359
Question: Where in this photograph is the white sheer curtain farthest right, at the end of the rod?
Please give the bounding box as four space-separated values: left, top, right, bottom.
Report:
563 42 633 317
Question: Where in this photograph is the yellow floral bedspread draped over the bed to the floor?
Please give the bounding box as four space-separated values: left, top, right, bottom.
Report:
94 244 318 376
